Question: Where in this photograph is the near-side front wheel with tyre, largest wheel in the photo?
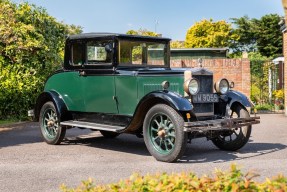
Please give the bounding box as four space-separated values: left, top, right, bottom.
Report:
143 104 187 162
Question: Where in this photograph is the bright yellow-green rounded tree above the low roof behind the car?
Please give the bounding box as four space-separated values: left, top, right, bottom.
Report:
185 19 238 48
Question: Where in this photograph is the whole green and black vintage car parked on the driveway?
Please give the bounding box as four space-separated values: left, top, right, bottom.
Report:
34 33 259 162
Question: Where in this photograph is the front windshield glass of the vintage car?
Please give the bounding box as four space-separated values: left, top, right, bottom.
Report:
119 40 167 66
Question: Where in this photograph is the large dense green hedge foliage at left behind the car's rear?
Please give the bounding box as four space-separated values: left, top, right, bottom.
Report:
0 0 81 119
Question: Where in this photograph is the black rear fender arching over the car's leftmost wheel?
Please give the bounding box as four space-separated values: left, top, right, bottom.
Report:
34 91 72 121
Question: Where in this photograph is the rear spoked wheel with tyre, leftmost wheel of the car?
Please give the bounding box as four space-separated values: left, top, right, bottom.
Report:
39 102 66 145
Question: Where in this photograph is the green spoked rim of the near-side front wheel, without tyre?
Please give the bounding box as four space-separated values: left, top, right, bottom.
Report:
148 113 175 155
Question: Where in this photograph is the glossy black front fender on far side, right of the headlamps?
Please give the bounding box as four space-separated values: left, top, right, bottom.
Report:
226 90 253 109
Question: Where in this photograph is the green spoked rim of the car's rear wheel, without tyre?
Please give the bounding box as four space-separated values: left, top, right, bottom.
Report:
42 108 59 140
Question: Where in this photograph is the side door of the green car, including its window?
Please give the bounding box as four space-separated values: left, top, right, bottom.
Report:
80 39 118 113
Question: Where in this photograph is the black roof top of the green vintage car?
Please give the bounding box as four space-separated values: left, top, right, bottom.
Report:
67 33 171 41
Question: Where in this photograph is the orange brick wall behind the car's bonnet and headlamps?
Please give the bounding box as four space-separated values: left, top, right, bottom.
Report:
171 59 252 97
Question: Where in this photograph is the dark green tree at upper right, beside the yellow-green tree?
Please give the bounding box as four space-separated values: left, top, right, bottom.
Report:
231 14 283 58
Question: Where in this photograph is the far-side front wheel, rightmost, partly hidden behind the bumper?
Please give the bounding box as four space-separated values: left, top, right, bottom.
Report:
212 105 251 151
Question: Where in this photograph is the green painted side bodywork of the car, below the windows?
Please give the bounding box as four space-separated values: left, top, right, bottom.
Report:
44 71 184 116
